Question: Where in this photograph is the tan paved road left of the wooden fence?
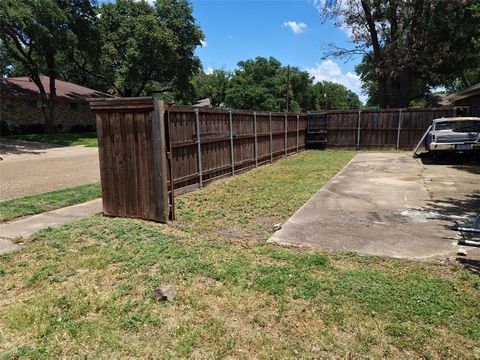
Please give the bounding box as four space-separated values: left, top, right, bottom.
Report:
0 139 100 200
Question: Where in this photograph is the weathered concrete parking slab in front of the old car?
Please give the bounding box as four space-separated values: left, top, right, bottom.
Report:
269 153 480 259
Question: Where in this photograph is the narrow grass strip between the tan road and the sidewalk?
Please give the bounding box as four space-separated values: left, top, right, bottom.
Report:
0 183 102 222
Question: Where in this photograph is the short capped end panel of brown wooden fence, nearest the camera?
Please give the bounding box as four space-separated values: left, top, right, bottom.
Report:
90 97 169 222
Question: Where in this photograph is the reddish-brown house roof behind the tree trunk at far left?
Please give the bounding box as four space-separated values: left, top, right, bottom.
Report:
0 75 111 100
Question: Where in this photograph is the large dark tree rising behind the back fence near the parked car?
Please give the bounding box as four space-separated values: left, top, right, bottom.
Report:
321 0 480 107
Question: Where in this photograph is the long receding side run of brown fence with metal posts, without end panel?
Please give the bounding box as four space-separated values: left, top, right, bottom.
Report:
167 106 307 190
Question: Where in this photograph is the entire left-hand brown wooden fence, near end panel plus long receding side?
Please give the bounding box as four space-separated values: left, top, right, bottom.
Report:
90 97 307 222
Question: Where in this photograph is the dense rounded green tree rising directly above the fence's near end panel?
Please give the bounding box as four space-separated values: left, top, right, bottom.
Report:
96 0 203 96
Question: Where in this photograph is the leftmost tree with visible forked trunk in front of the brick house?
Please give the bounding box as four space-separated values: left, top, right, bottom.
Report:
0 0 95 133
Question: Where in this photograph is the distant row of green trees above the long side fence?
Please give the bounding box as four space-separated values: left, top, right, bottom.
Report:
194 57 362 112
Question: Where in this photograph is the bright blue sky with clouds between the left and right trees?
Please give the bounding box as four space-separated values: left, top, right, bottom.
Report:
192 0 364 100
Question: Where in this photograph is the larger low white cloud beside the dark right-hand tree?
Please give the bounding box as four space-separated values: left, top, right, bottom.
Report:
305 60 366 102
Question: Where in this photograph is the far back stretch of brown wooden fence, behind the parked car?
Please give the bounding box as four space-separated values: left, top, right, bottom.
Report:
307 108 455 150
